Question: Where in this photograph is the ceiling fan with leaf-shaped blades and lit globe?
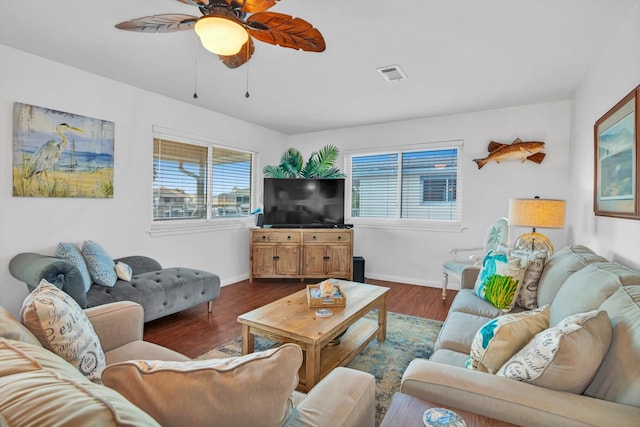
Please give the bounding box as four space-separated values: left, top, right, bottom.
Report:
116 0 325 68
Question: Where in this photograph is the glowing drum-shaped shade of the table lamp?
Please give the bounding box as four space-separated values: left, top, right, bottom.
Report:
508 199 566 228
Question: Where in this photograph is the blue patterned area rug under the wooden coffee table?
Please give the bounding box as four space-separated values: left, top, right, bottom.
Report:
198 312 442 425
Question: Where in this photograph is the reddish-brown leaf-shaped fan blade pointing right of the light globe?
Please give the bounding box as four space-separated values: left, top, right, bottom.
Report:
246 12 326 52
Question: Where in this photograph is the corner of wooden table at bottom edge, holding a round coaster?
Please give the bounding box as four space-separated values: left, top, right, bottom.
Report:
380 393 516 427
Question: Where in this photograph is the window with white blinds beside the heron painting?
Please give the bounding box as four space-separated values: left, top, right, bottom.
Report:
153 138 253 221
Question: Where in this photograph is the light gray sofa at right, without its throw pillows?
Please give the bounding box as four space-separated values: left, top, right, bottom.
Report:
401 246 640 427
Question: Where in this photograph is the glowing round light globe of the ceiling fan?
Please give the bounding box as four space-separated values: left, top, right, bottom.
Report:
195 16 249 56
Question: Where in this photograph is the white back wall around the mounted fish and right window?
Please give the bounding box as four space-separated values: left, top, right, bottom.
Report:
287 100 571 288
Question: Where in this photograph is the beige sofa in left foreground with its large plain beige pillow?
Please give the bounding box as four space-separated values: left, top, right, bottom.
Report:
0 301 375 427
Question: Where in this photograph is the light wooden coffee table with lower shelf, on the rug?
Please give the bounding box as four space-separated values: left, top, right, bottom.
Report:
238 280 389 392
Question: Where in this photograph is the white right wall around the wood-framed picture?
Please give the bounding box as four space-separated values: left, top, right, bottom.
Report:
568 4 640 268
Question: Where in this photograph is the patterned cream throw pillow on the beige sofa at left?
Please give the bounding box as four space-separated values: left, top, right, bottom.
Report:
20 279 105 383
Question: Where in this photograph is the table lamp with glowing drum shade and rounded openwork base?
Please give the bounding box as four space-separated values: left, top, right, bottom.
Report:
508 196 566 255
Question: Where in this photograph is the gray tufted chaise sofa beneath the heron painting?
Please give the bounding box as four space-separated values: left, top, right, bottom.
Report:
9 252 220 322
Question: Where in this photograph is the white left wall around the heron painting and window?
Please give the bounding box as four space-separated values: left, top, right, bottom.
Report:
0 45 285 314
